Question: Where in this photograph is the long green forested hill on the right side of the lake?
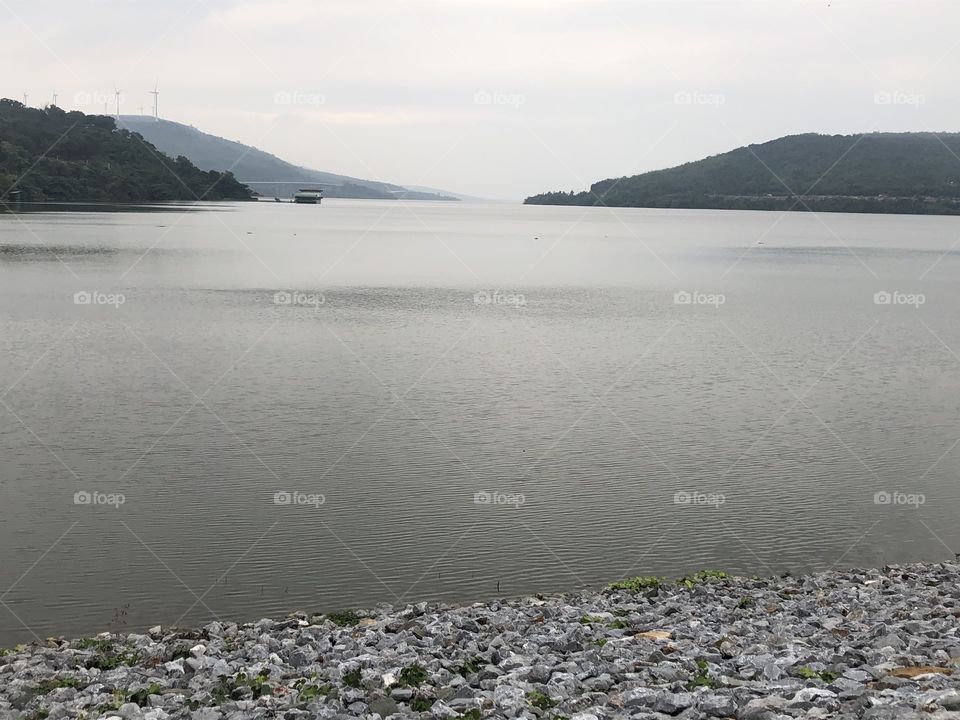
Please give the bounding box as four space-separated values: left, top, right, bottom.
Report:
526 133 960 214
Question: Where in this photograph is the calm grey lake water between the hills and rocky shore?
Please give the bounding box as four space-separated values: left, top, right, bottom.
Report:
0 200 960 645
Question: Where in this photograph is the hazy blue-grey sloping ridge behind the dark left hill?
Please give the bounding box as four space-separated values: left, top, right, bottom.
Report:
118 115 459 200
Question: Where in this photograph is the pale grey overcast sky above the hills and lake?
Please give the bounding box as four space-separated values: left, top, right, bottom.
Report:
0 0 960 199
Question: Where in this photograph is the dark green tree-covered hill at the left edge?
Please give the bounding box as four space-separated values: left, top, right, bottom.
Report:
0 99 251 208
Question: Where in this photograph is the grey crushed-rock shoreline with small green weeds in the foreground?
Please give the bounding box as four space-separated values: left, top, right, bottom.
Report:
0 563 960 720
